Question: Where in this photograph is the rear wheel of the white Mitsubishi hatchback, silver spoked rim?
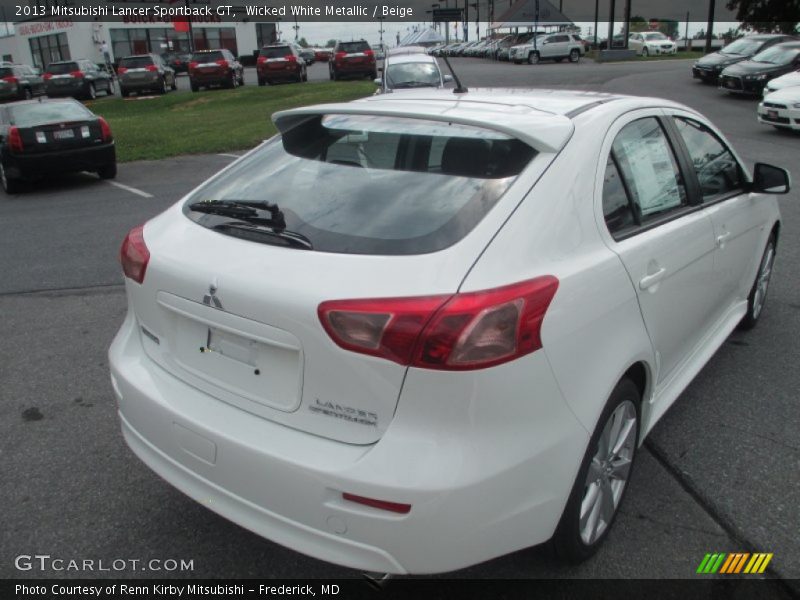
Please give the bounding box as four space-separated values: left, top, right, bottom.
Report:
552 378 641 563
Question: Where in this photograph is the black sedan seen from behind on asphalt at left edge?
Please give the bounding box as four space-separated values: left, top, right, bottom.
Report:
0 98 117 194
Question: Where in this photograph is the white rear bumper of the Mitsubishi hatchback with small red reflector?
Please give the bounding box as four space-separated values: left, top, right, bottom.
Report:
109 313 588 574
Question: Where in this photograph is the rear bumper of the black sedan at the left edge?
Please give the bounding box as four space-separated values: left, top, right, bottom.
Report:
6 142 117 178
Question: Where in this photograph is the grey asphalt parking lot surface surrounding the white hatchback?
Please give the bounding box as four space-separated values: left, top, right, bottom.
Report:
0 59 800 594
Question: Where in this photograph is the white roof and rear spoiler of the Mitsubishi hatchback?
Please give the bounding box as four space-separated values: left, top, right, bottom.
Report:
272 88 695 152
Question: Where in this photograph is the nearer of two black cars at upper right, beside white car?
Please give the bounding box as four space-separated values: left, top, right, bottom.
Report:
719 41 800 96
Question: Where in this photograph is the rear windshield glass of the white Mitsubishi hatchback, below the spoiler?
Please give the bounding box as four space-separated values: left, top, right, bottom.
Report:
184 115 535 255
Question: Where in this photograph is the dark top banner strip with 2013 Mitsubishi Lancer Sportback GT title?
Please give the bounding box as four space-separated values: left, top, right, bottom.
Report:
0 0 735 24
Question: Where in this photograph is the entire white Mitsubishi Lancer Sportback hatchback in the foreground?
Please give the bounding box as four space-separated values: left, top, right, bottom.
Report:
110 90 790 573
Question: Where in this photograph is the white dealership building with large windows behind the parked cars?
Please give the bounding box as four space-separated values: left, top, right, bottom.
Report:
0 16 280 69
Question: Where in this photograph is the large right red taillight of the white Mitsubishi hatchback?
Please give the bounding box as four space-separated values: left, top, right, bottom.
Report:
318 276 558 370
